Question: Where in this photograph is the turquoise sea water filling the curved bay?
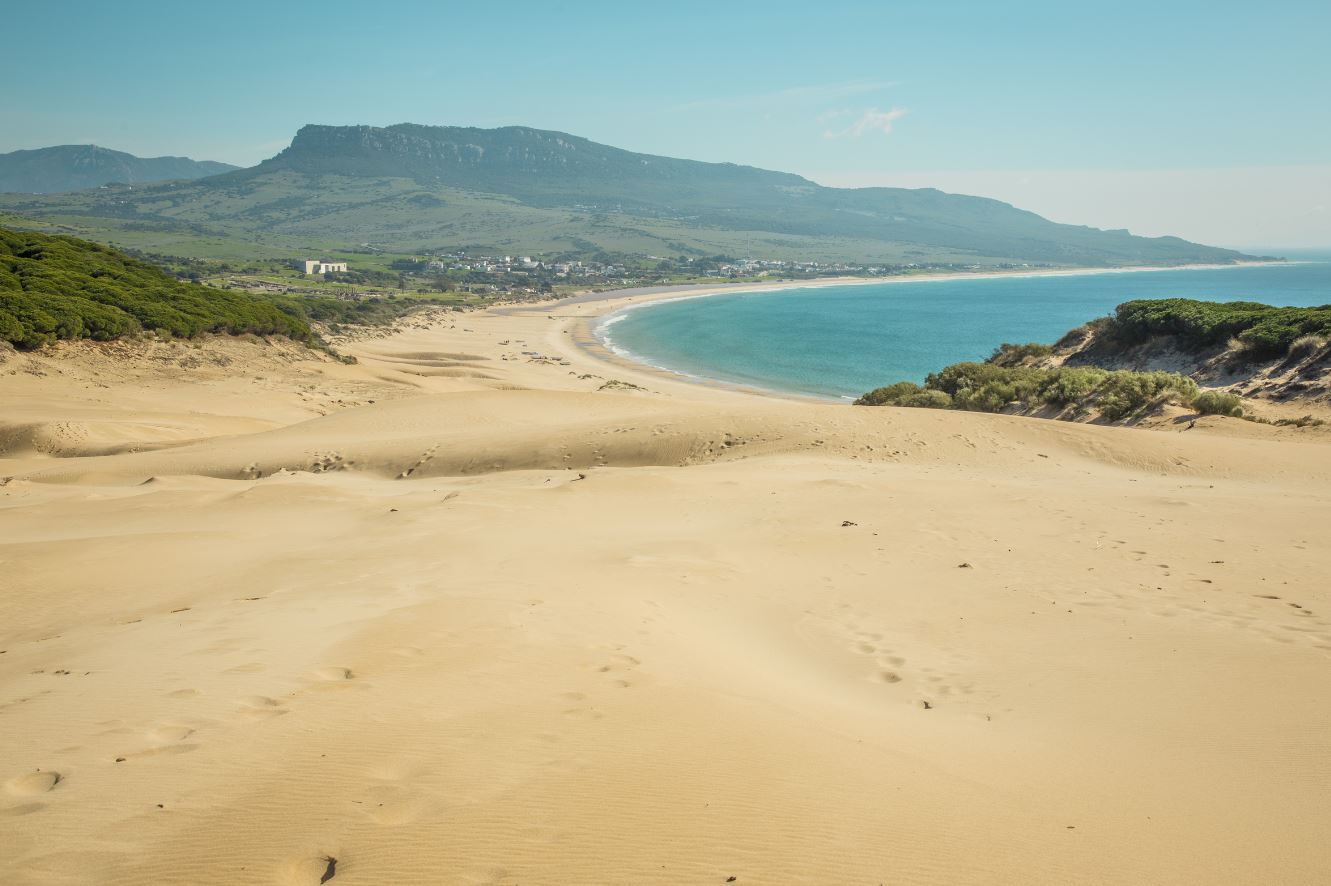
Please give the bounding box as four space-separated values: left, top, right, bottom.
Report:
596 261 1331 398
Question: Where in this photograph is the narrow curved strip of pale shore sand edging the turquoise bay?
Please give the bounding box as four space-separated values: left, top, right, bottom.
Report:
548 261 1303 404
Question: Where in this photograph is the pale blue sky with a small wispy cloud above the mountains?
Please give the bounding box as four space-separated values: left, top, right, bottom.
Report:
0 0 1331 246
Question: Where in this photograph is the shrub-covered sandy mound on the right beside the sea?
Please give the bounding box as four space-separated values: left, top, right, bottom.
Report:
856 298 1331 427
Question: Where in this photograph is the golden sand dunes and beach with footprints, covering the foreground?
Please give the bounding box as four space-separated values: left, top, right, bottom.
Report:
0 283 1331 886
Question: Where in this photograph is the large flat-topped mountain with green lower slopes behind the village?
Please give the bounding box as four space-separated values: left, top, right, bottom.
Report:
0 124 1244 266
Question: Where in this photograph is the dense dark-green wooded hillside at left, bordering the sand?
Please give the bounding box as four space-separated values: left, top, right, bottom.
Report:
0 229 310 347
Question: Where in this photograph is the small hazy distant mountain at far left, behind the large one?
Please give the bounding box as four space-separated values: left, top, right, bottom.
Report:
0 145 238 194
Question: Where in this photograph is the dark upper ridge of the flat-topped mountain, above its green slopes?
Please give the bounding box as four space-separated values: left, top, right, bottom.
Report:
212 124 1239 263
